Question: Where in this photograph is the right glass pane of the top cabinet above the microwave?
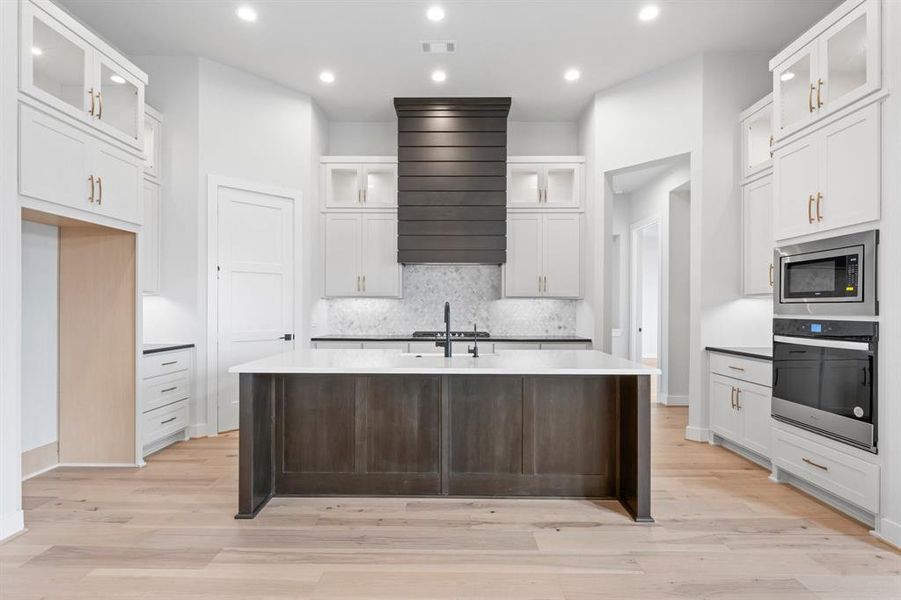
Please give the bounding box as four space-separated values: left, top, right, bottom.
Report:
823 13 867 108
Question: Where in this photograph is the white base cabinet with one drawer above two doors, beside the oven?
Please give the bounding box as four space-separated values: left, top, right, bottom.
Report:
709 353 772 458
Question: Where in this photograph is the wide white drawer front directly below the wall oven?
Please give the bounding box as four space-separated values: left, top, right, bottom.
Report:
773 428 879 513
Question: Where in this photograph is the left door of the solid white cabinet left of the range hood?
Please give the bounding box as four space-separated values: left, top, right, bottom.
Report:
323 214 362 297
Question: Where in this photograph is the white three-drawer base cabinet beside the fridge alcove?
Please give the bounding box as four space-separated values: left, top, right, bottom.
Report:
141 348 194 456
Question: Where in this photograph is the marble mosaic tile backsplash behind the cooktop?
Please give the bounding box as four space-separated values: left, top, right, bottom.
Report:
312 265 578 337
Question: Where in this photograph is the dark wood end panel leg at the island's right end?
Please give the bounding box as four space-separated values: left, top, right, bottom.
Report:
617 375 654 523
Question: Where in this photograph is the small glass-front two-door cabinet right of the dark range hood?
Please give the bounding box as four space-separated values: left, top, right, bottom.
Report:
507 156 582 209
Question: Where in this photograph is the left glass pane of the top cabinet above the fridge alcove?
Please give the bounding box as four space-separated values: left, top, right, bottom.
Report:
31 19 86 110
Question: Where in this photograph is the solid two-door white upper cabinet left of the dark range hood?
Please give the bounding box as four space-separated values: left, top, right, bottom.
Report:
323 212 401 298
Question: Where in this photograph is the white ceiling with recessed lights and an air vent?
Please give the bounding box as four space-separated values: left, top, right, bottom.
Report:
59 0 839 121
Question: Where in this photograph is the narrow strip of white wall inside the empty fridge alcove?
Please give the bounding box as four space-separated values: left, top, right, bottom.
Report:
22 221 59 452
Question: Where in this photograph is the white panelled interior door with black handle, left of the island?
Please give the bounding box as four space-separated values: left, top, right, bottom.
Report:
213 184 295 431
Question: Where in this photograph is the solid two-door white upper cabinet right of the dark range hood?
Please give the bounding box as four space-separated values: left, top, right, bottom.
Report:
504 212 582 298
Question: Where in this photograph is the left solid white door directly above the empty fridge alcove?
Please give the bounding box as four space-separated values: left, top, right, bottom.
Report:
19 105 93 210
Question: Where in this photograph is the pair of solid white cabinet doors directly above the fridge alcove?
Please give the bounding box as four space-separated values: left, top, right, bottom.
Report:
19 104 144 224
